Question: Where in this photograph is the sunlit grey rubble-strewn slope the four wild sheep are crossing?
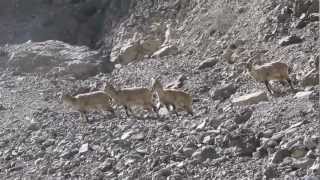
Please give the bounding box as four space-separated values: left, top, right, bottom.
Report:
0 0 320 180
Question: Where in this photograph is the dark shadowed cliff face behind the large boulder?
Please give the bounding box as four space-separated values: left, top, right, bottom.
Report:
0 0 130 48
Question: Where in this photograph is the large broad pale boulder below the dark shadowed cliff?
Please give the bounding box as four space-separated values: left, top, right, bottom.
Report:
6 40 113 78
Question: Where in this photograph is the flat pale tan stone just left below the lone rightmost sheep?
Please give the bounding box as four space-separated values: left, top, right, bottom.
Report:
232 91 268 105
